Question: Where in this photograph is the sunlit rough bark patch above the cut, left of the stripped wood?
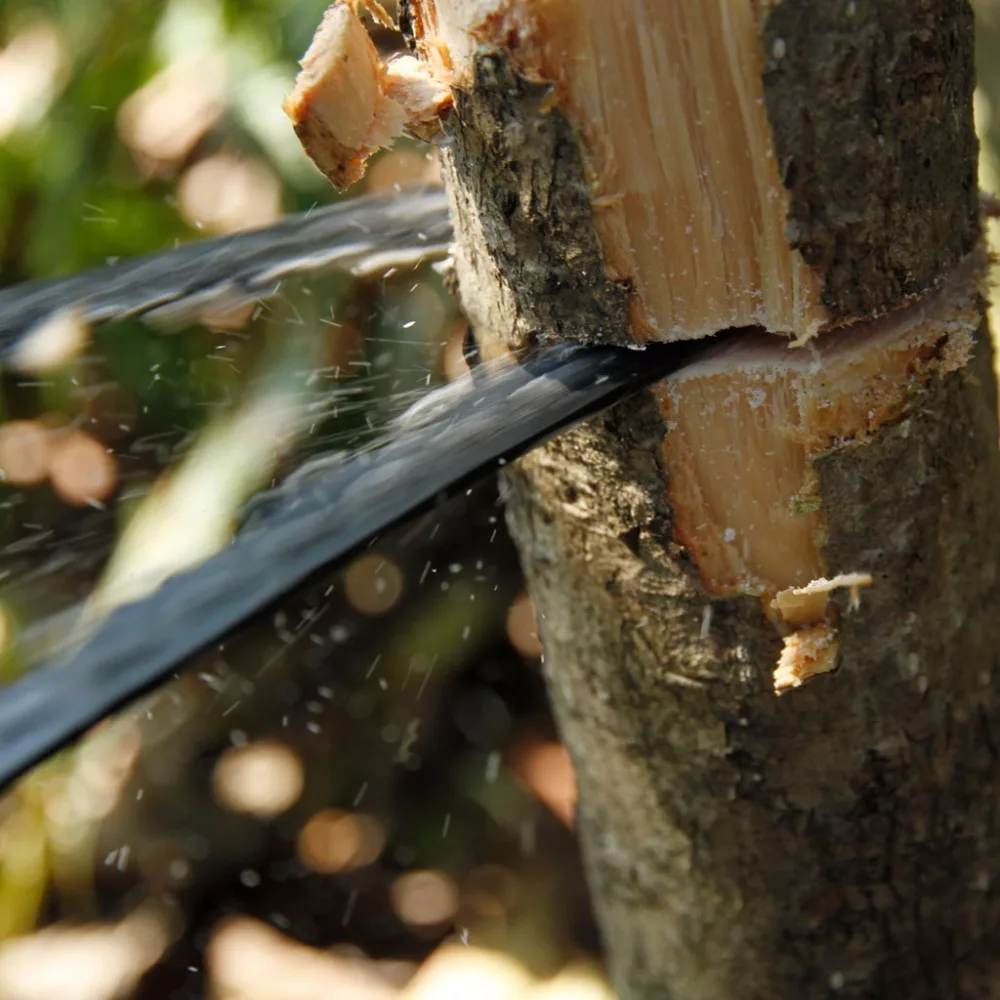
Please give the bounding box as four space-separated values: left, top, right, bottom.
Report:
448 54 632 348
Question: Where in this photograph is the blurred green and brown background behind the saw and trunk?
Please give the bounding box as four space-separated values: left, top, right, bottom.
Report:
0 0 1000 1000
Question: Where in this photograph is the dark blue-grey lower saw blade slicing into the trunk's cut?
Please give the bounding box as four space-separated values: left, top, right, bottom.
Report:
0 342 704 785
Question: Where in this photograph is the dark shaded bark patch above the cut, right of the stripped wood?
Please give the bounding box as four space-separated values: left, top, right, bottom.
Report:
763 0 979 320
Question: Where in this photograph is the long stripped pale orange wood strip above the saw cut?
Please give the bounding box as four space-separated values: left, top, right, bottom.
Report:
402 0 827 340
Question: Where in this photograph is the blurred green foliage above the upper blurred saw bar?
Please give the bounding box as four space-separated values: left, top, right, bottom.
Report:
0 0 327 284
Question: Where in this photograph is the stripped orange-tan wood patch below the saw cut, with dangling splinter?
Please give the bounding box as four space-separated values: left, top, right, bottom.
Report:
657 253 985 694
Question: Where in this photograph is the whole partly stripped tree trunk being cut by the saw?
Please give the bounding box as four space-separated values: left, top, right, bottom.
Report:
286 0 1000 1000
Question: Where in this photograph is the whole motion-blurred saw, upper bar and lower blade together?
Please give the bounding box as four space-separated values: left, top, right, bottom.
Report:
0 192 712 785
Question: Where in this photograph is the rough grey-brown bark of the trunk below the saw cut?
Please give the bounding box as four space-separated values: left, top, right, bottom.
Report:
507 332 1000 1000
